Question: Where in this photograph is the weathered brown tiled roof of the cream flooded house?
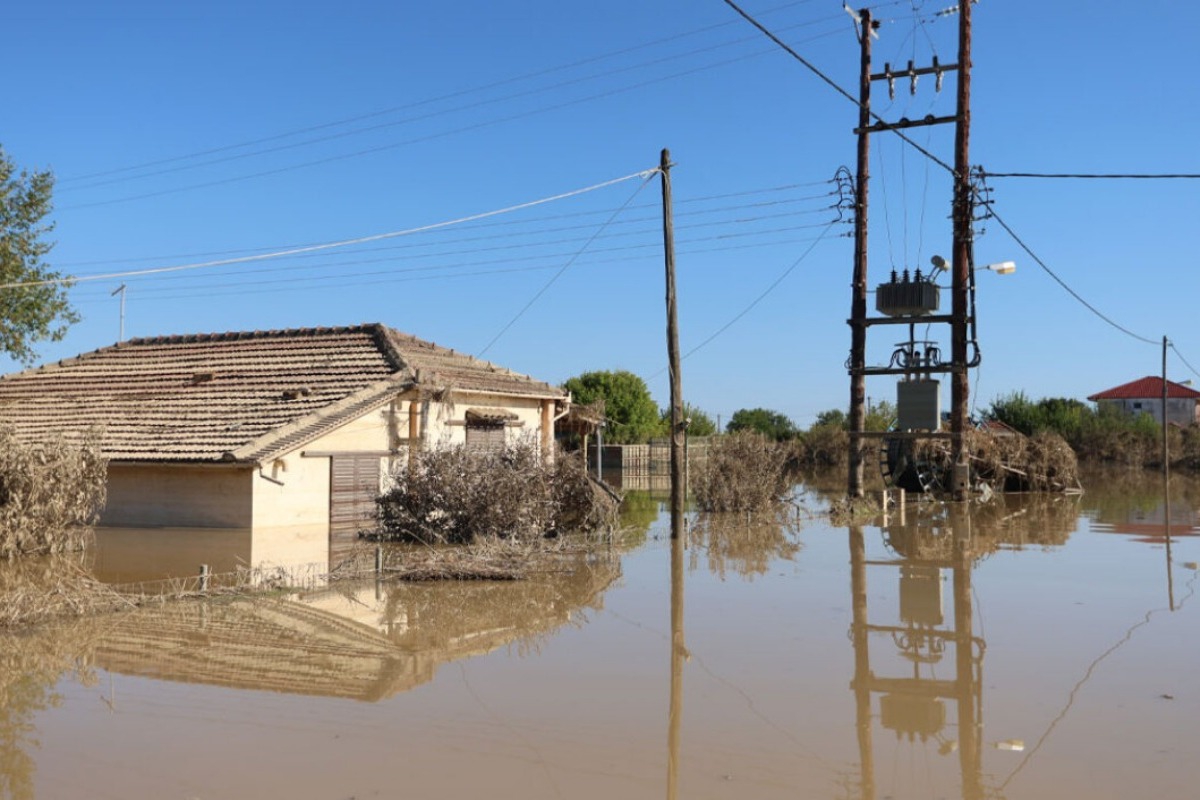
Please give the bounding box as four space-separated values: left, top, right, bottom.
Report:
0 324 565 462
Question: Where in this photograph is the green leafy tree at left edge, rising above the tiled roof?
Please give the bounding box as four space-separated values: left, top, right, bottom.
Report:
0 148 79 365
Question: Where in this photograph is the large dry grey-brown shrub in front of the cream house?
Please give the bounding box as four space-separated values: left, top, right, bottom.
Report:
379 441 618 545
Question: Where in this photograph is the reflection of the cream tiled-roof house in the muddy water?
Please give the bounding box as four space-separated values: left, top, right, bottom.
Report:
95 560 620 702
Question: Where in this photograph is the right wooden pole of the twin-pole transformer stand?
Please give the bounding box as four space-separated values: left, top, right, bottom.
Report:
950 0 974 500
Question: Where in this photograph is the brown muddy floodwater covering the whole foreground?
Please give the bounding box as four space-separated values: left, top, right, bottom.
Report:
0 476 1200 800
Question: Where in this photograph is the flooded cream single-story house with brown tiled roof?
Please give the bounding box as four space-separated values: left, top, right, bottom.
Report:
0 324 570 566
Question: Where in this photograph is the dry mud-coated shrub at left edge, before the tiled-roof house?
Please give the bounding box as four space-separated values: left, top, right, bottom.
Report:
0 427 108 559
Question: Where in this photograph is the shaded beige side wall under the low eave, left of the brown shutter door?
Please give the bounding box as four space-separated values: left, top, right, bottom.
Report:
100 464 253 528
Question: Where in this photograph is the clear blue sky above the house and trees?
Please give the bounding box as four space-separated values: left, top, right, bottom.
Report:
0 0 1200 425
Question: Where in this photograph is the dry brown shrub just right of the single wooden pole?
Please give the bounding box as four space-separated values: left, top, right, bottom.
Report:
695 432 794 511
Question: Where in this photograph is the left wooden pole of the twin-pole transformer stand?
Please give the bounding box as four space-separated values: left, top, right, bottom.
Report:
846 8 871 498
